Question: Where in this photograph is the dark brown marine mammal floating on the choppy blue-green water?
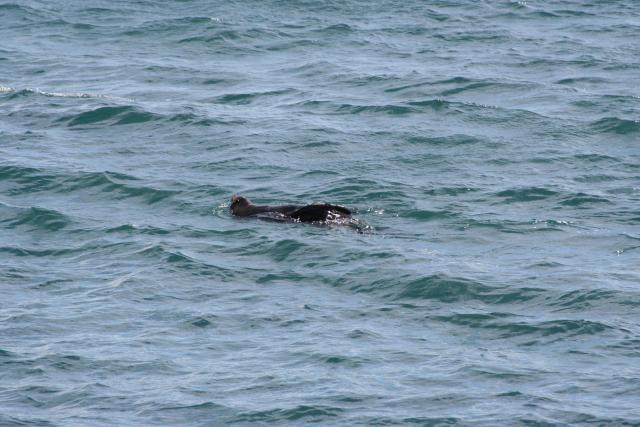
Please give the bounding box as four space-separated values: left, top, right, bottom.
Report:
229 194 351 222
